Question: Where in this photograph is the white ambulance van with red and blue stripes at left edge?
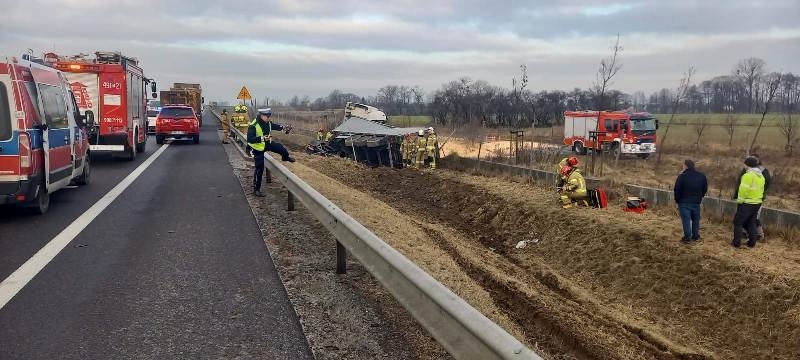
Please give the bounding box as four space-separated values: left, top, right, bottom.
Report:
0 56 94 214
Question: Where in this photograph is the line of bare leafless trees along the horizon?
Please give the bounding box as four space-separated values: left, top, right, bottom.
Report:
270 56 800 127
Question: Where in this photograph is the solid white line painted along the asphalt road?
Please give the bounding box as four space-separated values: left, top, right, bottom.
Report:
0 144 169 309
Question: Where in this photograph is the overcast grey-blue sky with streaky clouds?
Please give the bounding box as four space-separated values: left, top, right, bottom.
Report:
0 0 800 100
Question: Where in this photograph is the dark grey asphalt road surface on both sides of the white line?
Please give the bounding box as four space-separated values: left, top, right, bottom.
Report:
0 114 312 359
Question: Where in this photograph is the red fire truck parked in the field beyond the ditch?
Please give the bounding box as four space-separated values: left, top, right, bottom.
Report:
564 111 658 158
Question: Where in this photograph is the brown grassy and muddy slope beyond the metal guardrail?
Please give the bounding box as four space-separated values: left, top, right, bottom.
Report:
280 140 800 359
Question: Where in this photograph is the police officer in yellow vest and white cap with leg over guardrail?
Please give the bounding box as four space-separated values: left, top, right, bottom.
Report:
247 108 294 197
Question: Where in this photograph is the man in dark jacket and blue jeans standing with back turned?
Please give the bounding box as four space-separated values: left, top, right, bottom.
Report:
675 159 708 244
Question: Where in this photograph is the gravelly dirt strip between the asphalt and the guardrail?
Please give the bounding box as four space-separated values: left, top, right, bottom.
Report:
225 140 451 360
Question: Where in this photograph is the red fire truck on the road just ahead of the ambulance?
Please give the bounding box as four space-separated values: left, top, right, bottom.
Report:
52 51 155 161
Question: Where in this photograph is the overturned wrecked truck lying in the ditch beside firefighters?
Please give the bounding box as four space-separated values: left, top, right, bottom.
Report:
322 103 424 168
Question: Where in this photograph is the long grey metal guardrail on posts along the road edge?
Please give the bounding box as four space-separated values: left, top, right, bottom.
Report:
212 111 541 360
